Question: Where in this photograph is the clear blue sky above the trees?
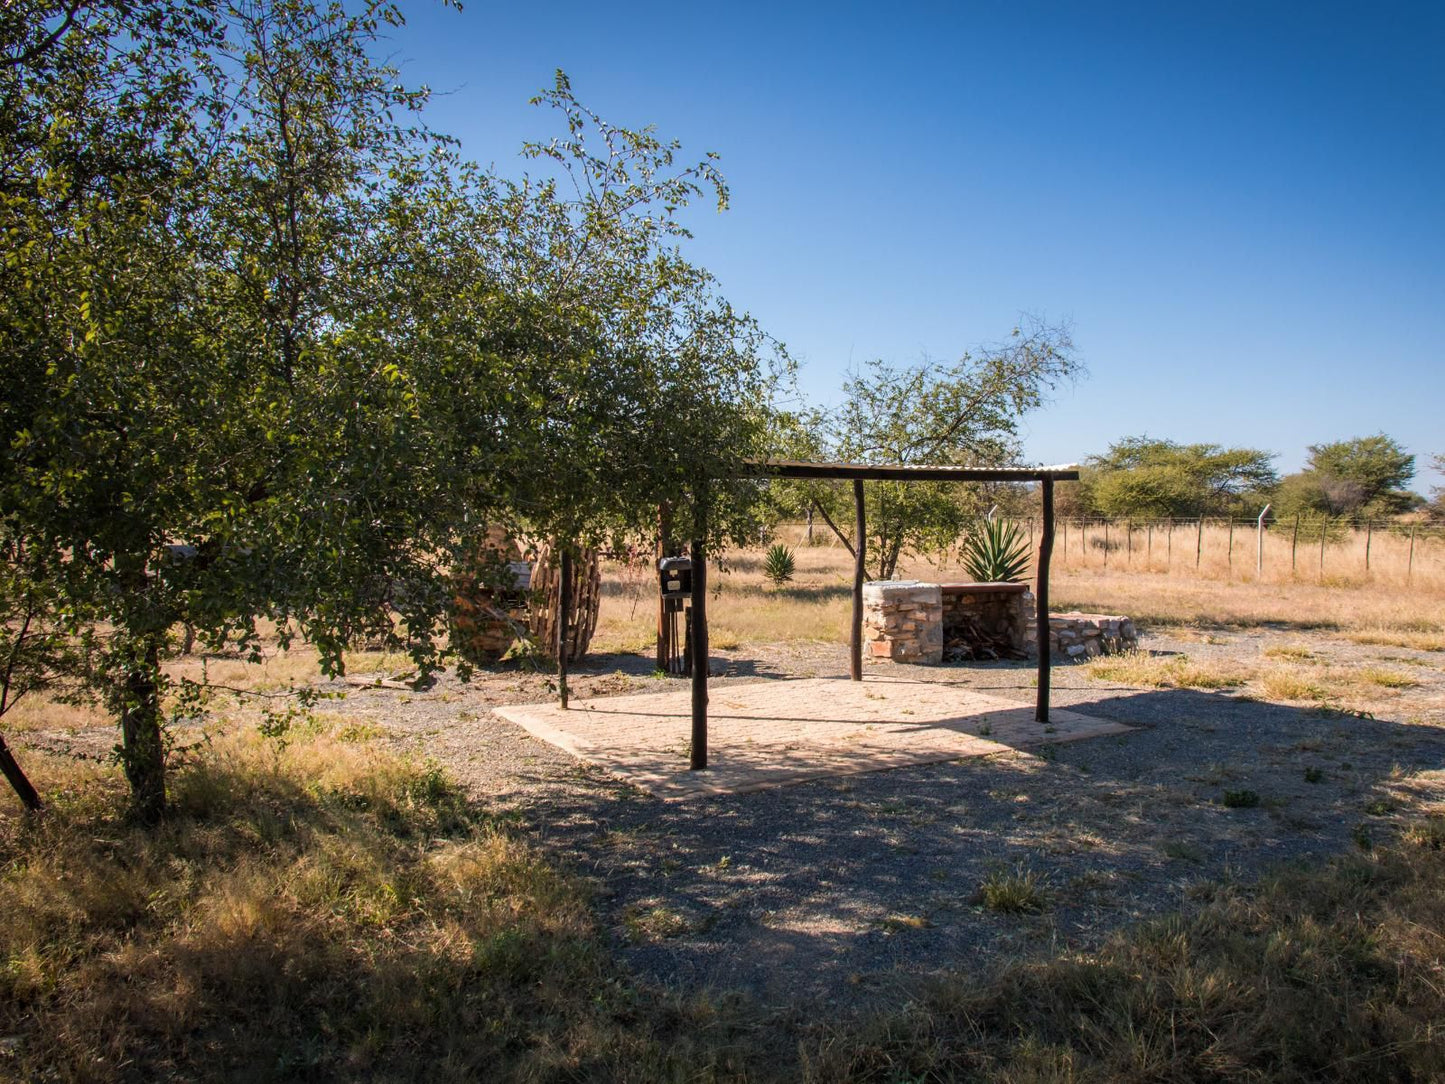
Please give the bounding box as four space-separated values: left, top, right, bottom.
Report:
393 0 1445 491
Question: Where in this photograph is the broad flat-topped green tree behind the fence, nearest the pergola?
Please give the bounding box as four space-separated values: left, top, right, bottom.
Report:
1085 436 1279 519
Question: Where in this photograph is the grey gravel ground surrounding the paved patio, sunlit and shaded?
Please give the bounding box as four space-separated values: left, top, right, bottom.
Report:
20 629 1445 1005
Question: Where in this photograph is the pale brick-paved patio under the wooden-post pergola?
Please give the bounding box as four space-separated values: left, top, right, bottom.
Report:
494 676 1130 798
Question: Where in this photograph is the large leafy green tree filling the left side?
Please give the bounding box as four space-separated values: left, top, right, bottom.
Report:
0 0 791 820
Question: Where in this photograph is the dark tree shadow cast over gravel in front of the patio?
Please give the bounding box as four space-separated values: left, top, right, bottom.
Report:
502 679 1445 1000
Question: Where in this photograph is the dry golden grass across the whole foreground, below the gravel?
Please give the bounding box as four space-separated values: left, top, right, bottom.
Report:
8 696 1445 1084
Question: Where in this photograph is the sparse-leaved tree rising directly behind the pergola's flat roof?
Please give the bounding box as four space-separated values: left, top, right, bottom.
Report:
803 318 1082 580
